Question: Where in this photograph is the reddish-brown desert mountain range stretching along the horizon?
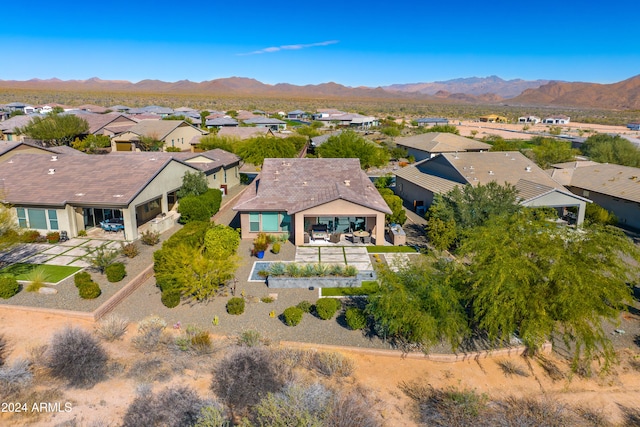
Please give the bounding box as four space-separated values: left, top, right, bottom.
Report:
0 75 640 110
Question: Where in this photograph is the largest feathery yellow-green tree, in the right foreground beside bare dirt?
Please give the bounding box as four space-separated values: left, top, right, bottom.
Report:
458 213 640 368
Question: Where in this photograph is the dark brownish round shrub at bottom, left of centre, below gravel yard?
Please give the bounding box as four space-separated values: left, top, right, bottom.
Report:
211 347 287 414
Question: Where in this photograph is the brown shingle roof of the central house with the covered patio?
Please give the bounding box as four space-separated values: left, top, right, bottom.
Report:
233 158 391 214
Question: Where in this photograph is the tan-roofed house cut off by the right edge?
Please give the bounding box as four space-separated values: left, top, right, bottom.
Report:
550 161 640 230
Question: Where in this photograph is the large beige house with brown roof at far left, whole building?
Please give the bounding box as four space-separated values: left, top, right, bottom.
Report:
0 153 198 240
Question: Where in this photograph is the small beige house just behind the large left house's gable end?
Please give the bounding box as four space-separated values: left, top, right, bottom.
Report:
168 148 240 195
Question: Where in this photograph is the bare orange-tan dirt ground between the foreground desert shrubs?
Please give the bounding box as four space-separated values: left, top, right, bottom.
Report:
0 309 640 426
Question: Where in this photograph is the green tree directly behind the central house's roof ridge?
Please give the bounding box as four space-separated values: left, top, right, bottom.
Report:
316 130 389 169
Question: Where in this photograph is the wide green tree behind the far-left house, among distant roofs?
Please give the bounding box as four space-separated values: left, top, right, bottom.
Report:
17 113 89 146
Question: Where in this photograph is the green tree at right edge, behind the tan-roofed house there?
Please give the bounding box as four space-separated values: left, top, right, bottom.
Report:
581 133 640 168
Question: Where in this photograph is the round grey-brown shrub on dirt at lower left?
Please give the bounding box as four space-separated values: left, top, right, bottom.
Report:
45 327 109 387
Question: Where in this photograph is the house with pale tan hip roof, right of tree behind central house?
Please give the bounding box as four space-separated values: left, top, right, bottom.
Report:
396 132 491 161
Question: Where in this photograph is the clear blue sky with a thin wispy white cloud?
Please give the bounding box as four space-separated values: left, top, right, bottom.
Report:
0 0 640 86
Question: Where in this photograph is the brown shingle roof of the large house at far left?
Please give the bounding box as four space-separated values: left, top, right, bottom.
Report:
0 154 196 207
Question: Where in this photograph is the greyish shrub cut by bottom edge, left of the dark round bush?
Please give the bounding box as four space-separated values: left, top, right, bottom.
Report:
122 387 205 427
